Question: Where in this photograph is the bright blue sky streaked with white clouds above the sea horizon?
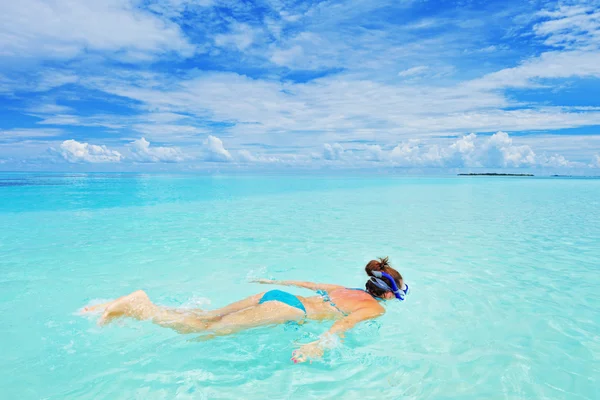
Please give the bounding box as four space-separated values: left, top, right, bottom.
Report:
0 0 600 170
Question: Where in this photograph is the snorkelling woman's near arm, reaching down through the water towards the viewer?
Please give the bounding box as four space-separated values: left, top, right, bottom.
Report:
292 306 385 363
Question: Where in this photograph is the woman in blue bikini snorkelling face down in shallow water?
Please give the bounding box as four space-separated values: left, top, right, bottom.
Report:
84 257 408 362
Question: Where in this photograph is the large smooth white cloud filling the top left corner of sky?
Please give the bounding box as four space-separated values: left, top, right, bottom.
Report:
0 0 194 59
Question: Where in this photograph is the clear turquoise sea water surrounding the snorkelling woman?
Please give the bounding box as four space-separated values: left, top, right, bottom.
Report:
0 173 600 399
